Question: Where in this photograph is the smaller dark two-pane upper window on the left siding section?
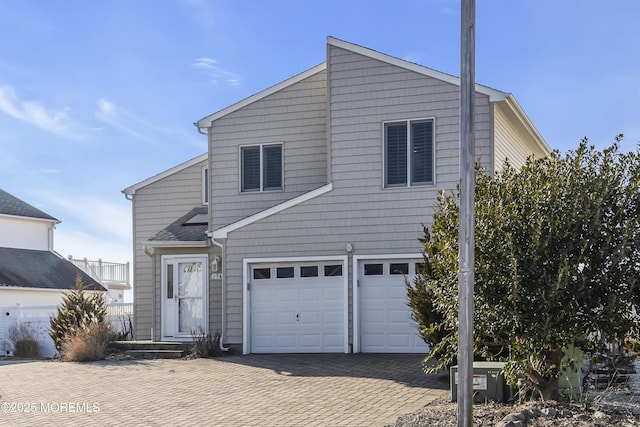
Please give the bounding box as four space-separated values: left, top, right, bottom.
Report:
240 144 282 192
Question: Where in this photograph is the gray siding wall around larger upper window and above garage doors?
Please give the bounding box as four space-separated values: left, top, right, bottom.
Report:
214 47 493 344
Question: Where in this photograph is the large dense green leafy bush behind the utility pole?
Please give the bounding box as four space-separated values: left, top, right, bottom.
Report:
408 136 640 399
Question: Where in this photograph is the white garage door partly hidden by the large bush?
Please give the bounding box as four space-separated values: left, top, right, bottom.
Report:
358 260 429 353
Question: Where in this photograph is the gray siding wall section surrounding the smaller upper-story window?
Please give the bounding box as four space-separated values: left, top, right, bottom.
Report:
209 71 327 228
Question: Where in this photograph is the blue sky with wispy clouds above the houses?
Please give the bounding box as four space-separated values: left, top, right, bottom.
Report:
0 0 640 268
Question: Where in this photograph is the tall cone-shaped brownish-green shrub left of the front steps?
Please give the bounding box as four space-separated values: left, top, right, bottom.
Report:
49 274 110 358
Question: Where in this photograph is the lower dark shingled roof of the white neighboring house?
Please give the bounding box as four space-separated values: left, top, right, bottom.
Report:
0 248 106 291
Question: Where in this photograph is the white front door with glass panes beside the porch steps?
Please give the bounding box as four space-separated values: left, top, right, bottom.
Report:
161 255 208 339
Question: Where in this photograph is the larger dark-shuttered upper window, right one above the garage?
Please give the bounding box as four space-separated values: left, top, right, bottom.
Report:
384 119 434 187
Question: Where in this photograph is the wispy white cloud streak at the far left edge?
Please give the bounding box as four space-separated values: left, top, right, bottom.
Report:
0 85 77 137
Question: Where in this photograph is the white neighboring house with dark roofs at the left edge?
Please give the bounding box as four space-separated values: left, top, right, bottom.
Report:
0 189 105 356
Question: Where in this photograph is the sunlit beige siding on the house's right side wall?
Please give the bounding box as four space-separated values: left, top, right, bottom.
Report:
494 102 548 170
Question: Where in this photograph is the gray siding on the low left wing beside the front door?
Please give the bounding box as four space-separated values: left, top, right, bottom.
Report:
133 161 206 339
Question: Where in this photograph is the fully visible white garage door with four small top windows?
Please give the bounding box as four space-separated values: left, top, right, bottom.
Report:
249 262 345 353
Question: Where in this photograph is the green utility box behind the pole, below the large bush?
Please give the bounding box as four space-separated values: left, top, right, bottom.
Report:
449 362 513 403
